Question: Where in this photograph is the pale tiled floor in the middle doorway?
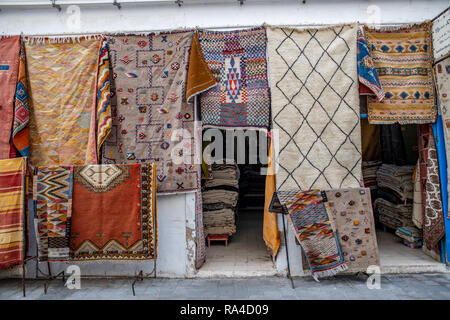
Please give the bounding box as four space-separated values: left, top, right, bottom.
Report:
197 210 276 277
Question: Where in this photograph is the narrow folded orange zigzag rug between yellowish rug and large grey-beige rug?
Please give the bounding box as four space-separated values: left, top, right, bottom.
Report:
86 39 112 163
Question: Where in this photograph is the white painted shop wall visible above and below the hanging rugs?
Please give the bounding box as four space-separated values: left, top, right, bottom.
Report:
0 0 449 277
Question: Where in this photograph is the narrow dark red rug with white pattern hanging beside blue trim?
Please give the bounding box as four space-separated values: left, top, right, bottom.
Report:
418 124 445 256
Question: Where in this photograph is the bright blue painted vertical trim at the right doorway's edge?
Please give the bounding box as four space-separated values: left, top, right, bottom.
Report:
433 115 450 264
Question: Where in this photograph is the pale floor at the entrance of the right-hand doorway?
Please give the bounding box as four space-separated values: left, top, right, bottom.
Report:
377 230 446 273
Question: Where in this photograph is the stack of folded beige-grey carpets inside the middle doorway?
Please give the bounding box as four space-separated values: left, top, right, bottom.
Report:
202 163 239 236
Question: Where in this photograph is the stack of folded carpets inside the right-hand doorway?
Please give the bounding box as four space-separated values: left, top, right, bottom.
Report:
375 164 414 229
